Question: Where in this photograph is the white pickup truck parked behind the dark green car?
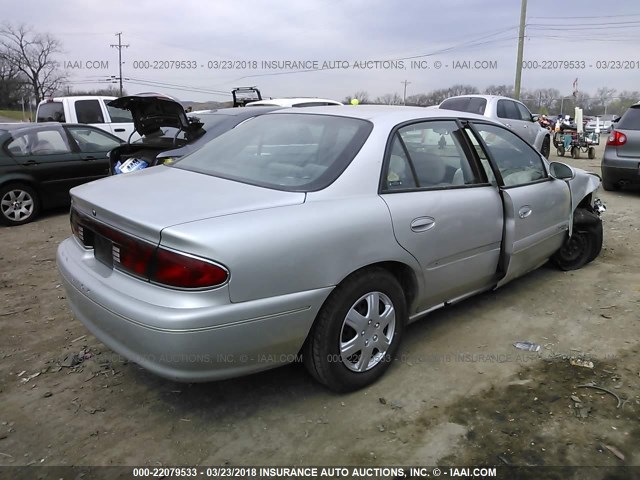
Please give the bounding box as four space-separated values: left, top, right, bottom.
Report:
36 96 139 141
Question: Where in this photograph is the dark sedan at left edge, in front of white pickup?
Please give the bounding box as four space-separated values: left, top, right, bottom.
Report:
0 123 122 225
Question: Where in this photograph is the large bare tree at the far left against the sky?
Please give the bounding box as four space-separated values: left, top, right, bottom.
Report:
0 23 65 102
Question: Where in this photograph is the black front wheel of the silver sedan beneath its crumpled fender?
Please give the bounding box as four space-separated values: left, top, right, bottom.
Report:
551 208 603 271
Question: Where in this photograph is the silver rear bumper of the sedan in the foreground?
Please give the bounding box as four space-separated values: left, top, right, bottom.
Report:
57 238 332 382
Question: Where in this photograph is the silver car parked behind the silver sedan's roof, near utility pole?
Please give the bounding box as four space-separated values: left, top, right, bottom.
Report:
439 95 551 158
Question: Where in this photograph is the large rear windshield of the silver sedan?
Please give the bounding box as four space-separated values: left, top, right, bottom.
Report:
175 113 372 192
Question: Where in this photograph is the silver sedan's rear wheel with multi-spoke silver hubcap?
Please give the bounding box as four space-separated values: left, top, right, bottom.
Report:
303 268 407 392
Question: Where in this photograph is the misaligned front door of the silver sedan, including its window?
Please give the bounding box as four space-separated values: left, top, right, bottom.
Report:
473 123 571 286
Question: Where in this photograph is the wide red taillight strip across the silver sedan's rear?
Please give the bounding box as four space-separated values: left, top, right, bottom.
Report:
71 210 229 289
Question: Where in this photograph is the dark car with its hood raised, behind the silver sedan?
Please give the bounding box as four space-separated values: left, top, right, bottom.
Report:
109 93 279 174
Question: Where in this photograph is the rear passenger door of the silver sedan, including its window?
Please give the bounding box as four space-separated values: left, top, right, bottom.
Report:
380 120 502 310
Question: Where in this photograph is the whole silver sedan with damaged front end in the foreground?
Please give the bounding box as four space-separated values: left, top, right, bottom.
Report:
57 106 602 391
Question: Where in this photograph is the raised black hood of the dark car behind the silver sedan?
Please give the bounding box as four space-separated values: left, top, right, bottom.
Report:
108 93 202 136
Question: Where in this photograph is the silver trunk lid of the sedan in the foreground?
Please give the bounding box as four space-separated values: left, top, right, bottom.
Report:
71 166 306 242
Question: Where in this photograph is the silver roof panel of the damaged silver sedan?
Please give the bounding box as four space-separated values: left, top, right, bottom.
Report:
269 105 497 123
